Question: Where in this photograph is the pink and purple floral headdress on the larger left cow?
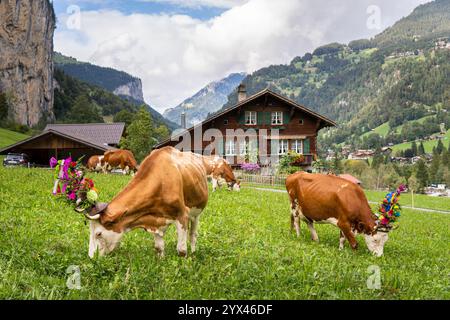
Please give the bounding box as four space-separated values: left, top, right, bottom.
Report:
50 157 98 212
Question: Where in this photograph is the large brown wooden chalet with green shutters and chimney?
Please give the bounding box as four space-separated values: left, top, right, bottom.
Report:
155 85 336 170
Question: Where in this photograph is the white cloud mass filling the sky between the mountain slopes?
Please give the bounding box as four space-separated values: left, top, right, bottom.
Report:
55 0 426 111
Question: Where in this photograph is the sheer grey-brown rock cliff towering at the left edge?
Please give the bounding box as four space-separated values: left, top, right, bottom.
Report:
0 0 55 126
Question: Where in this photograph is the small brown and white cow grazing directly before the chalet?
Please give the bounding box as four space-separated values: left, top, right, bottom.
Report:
203 156 241 192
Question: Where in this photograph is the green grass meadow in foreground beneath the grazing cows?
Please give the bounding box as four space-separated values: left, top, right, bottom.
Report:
0 167 450 299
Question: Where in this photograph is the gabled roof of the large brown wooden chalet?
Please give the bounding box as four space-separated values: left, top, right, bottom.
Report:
154 88 337 148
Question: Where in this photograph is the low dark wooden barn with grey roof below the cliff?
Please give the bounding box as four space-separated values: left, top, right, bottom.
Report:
0 123 125 166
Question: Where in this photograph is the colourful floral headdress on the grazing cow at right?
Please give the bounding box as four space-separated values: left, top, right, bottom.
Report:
376 185 406 231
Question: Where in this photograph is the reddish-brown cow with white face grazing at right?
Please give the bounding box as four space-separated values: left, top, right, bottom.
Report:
286 172 388 256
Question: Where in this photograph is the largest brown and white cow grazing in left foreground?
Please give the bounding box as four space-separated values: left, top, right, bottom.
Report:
85 147 208 257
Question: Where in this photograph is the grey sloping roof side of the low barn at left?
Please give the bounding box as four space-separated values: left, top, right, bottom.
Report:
44 122 125 147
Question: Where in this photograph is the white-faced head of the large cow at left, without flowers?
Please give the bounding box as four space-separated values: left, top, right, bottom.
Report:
85 203 123 258
